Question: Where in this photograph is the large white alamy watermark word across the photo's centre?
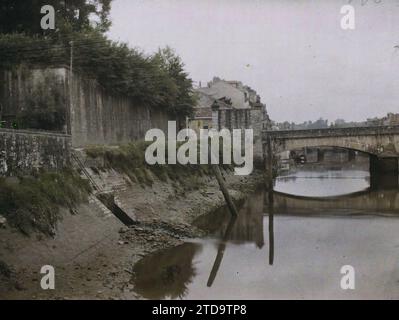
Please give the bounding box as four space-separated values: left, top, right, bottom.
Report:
145 121 254 176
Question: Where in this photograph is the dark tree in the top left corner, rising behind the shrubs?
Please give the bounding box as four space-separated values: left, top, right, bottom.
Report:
0 0 112 35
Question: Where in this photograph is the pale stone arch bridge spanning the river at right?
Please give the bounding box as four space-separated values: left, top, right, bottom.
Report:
262 125 399 174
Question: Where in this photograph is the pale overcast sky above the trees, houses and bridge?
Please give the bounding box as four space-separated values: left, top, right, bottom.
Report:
109 0 399 122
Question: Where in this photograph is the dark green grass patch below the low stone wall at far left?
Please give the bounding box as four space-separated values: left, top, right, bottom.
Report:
0 169 90 235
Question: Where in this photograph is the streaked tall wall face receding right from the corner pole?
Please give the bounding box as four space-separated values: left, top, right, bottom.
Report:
66 70 168 147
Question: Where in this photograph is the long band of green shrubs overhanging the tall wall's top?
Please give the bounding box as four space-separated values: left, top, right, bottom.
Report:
0 30 195 118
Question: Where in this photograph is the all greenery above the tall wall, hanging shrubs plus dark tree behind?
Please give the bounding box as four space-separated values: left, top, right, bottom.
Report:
0 0 195 118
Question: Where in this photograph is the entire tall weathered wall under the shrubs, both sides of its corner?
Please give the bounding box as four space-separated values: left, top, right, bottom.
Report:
0 66 169 147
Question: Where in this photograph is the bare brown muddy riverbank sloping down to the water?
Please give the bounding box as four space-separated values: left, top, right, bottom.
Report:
0 164 262 299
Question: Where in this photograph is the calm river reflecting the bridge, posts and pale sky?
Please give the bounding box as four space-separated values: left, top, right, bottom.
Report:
134 168 399 300
